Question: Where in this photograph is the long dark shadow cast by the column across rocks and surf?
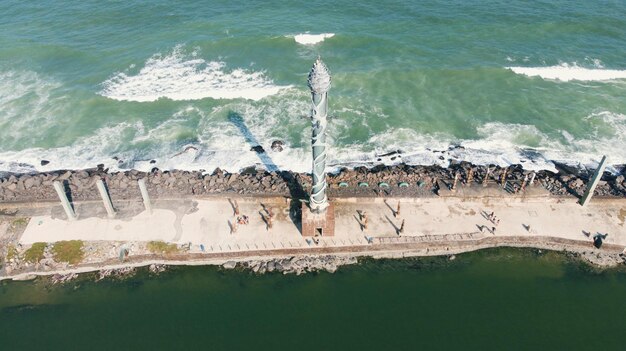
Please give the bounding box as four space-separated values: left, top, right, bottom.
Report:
228 111 307 233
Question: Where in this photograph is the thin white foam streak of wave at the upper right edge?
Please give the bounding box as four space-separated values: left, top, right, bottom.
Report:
507 60 626 82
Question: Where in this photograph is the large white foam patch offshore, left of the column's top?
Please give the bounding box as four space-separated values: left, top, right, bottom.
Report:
100 46 288 101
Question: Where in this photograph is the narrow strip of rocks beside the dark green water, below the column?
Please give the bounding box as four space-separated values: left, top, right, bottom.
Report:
223 255 358 275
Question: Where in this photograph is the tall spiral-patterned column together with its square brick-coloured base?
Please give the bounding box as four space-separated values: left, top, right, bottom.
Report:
302 57 335 236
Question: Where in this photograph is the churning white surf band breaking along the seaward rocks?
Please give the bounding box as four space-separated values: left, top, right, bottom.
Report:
0 110 626 172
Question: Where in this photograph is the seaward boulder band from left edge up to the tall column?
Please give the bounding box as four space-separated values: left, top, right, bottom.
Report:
0 168 304 202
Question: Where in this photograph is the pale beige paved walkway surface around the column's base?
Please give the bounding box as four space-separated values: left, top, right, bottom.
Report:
20 197 626 252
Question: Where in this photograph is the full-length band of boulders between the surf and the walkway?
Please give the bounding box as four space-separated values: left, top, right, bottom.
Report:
0 162 626 202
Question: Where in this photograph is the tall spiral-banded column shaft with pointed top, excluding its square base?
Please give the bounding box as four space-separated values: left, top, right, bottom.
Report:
307 57 330 213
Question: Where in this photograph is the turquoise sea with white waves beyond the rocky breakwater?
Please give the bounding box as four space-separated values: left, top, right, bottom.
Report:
0 0 626 171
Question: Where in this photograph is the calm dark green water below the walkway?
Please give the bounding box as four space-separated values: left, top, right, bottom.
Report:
0 250 626 350
